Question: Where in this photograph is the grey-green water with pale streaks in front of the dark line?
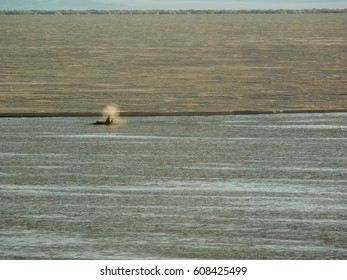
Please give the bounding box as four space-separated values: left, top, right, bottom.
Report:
0 113 347 259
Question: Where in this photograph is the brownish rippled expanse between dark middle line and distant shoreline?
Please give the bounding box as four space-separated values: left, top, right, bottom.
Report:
0 14 347 113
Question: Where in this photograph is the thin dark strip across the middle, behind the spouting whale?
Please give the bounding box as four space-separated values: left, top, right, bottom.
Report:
0 108 347 118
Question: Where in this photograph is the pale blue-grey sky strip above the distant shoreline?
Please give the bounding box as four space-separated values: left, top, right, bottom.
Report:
0 0 347 10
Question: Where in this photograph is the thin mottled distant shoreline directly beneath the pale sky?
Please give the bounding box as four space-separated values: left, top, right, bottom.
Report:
0 8 347 15
